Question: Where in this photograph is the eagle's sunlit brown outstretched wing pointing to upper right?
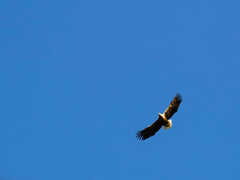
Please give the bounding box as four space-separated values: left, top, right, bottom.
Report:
163 94 182 119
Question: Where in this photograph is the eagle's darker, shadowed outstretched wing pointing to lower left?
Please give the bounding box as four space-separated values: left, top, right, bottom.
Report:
137 116 163 140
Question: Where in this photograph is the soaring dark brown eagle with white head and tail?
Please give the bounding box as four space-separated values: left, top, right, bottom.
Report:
137 94 182 140
